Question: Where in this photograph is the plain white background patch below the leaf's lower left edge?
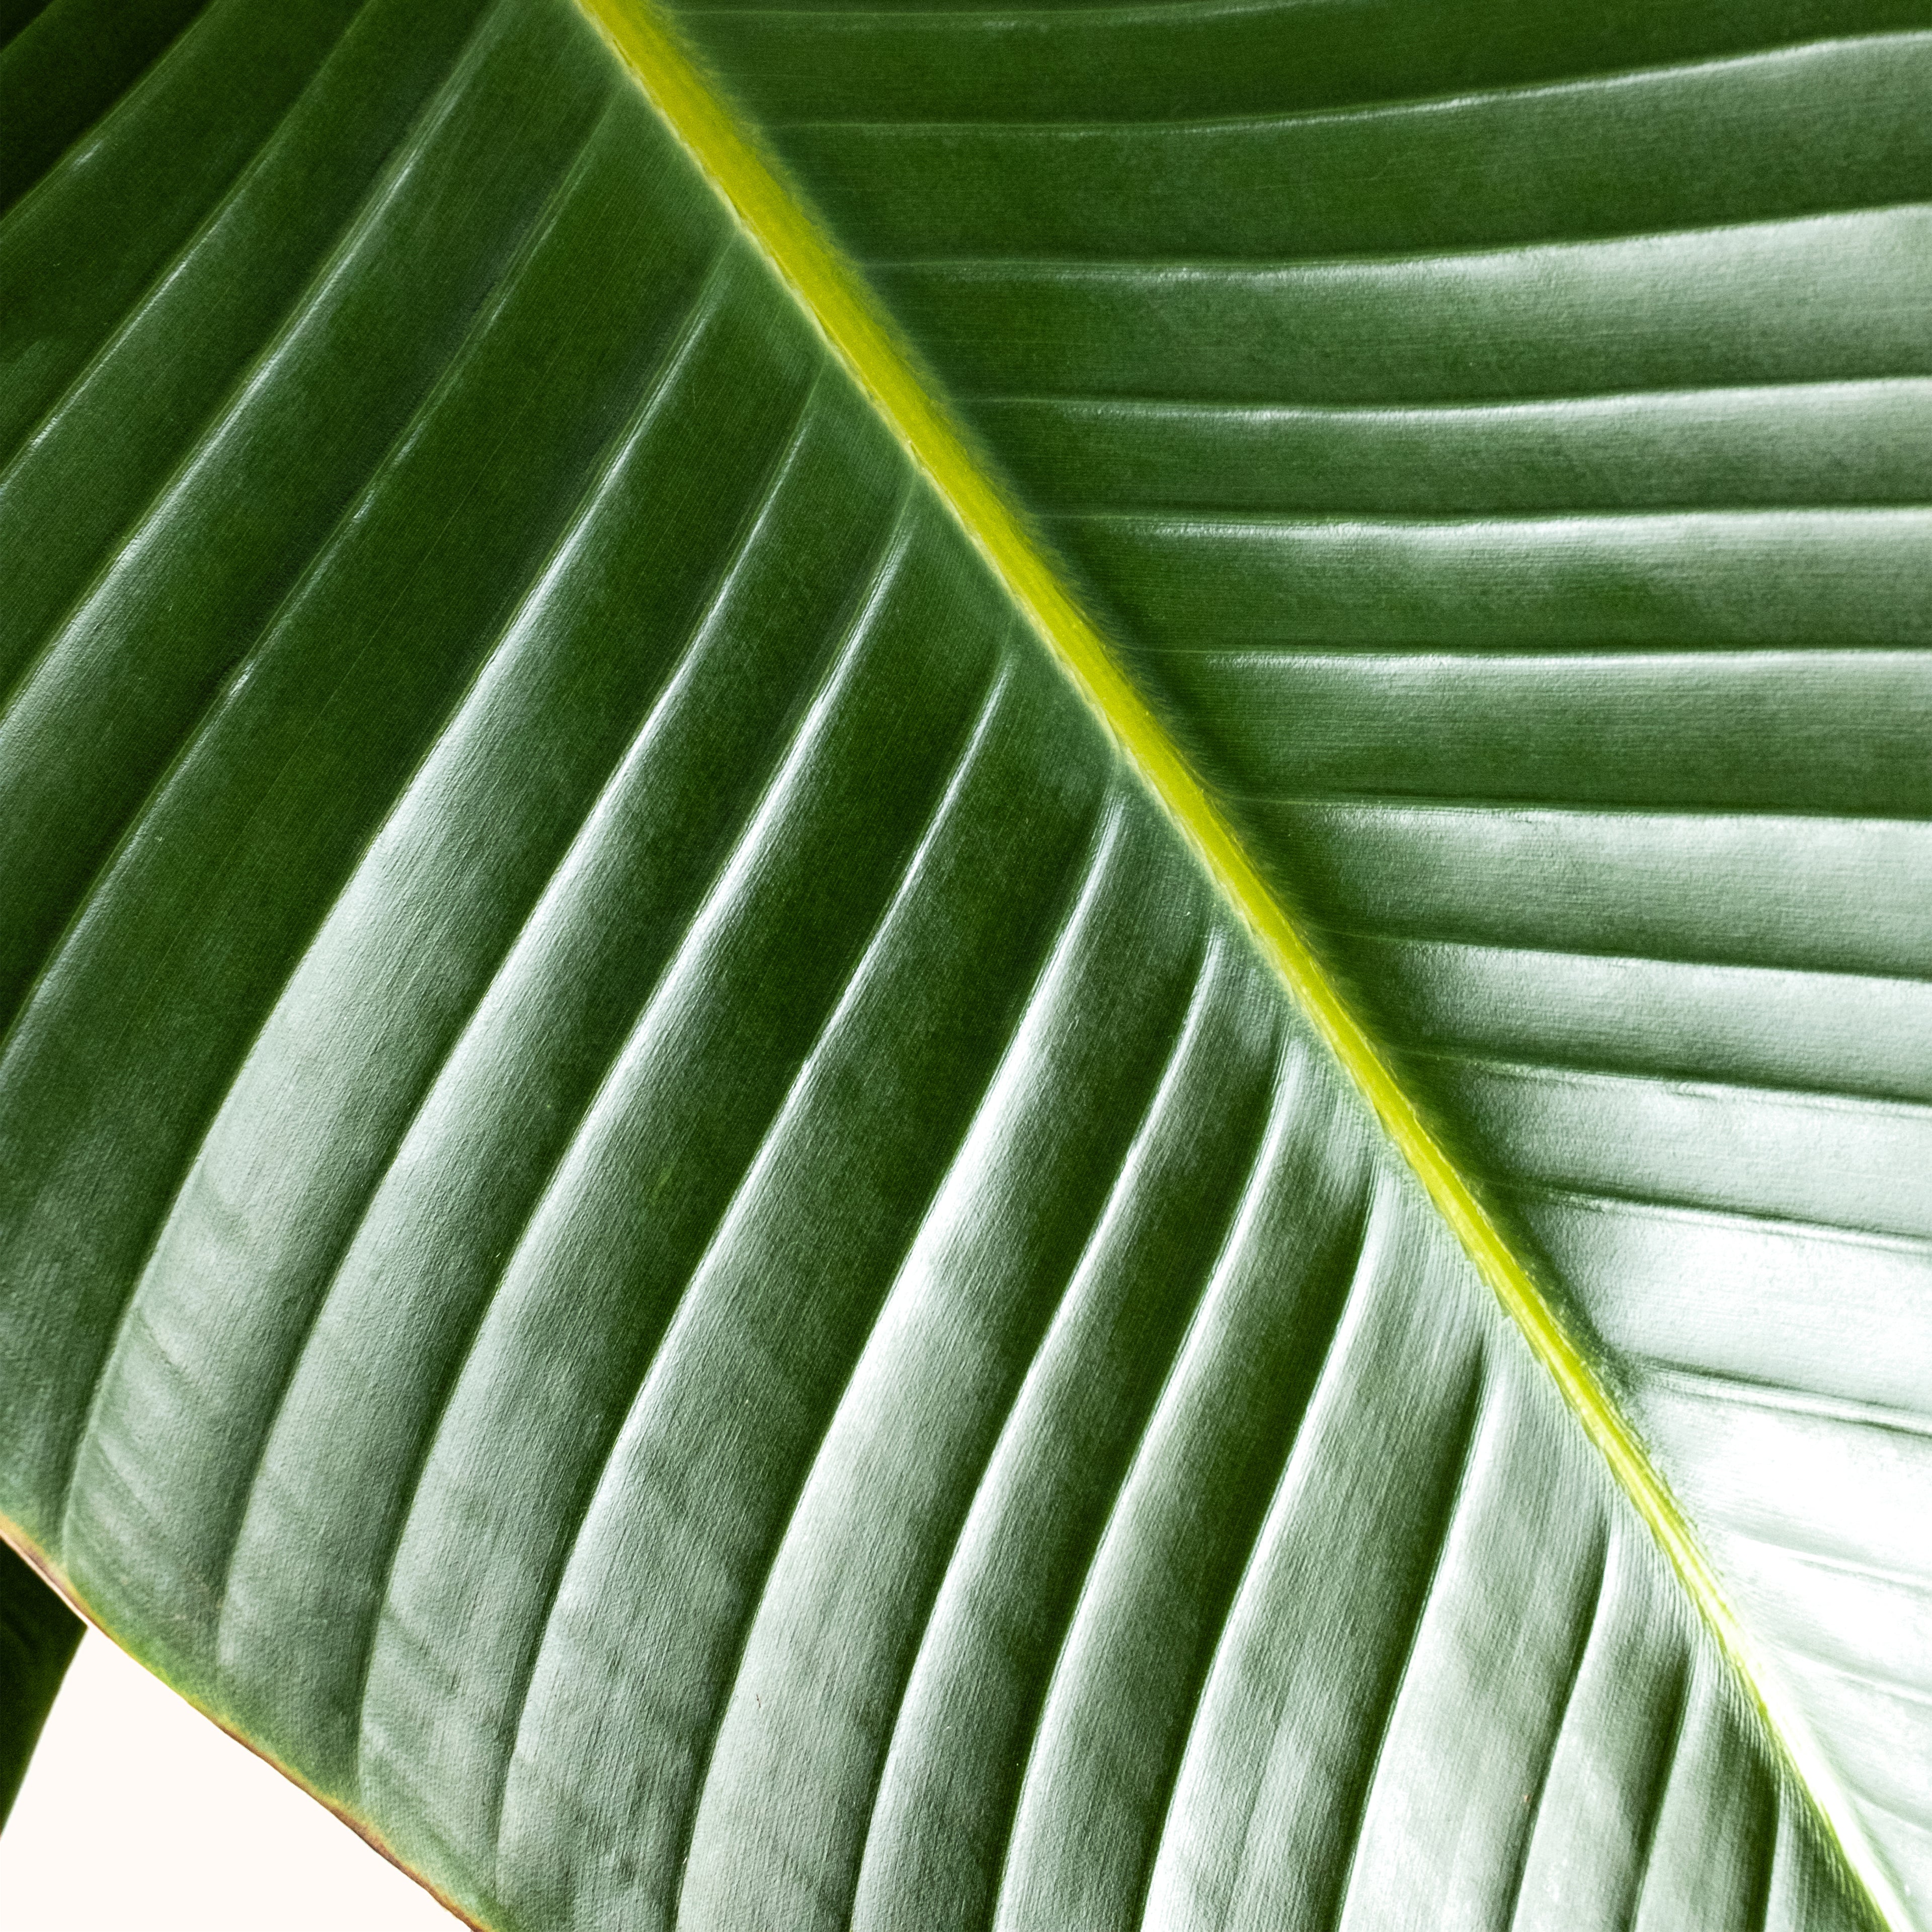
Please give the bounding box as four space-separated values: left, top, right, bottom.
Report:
0 1631 462 1932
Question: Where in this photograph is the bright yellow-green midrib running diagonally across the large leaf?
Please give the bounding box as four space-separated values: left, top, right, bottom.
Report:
578 0 1890 1903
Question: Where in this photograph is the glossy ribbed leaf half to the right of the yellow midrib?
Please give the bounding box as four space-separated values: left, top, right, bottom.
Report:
661 0 1932 1911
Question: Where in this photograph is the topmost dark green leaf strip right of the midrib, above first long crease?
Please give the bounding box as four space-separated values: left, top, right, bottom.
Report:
678 0 1924 124
